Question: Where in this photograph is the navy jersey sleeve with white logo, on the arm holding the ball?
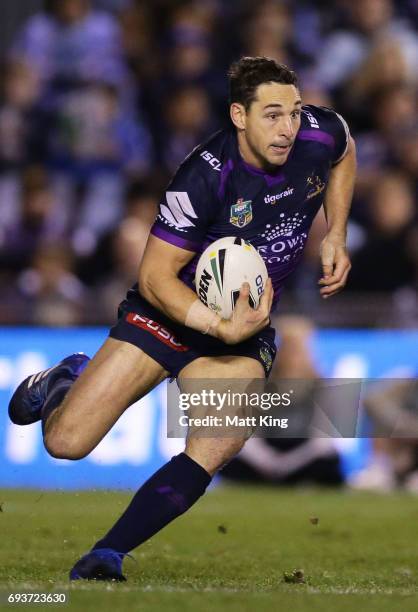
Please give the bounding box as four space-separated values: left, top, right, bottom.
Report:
151 161 215 252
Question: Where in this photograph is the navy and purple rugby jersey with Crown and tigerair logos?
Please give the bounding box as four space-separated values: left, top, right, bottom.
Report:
151 106 349 303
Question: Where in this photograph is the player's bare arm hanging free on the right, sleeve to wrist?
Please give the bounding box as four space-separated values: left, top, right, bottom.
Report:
324 138 357 244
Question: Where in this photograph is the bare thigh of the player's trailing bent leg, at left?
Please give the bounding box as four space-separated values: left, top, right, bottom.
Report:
45 338 167 451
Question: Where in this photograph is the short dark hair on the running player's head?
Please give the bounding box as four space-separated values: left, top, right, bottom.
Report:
228 57 298 110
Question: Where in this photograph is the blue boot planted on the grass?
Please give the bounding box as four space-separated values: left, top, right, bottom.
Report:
70 548 126 582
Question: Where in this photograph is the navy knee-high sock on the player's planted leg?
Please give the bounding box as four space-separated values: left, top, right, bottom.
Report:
93 453 211 553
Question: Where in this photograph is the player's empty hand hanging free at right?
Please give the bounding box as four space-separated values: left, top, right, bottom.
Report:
318 234 351 299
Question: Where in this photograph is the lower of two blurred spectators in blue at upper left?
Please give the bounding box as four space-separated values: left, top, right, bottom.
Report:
48 85 152 254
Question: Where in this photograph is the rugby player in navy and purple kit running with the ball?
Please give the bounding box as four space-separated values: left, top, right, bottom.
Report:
9 57 356 580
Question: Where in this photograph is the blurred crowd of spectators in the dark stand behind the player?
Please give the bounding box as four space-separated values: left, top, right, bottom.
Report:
0 0 418 326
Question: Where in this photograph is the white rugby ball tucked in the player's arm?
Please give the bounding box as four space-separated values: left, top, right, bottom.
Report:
195 236 268 319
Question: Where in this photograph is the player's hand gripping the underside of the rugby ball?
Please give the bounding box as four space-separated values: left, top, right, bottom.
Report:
216 278 273 344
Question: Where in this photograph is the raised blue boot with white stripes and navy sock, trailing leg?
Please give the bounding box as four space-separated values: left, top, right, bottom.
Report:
9 353 90 425
